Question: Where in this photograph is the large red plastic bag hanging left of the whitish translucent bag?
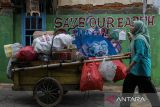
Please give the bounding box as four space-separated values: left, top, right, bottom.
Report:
80 62 103 91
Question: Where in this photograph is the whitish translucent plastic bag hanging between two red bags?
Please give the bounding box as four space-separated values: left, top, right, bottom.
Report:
99 58 117 81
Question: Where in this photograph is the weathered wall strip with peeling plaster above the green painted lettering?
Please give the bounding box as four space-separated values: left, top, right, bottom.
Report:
56 0 159 15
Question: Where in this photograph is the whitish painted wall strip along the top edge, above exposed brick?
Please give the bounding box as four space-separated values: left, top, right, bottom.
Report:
58 0 153 6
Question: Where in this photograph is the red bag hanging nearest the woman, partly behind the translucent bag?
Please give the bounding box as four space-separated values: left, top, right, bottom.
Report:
112 60 127 82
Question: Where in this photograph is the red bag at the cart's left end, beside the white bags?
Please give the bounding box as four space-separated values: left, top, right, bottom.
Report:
16 46 36 61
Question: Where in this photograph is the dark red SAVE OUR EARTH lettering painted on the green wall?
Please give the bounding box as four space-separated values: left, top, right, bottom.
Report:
54 15 155 29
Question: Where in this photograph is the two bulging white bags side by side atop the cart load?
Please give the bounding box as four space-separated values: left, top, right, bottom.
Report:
32 33 73 54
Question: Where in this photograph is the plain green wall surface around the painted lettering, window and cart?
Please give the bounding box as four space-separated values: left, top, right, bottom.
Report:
0 14 160 86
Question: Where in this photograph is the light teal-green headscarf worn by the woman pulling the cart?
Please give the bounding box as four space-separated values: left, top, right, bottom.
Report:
131 20 150 55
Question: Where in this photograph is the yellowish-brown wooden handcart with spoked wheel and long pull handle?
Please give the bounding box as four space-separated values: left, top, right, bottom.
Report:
12 56 129 107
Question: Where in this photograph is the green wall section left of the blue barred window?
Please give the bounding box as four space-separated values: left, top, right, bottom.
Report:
0 9 21 82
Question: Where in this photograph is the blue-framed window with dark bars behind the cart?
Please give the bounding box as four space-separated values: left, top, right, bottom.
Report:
22 0 46 46
